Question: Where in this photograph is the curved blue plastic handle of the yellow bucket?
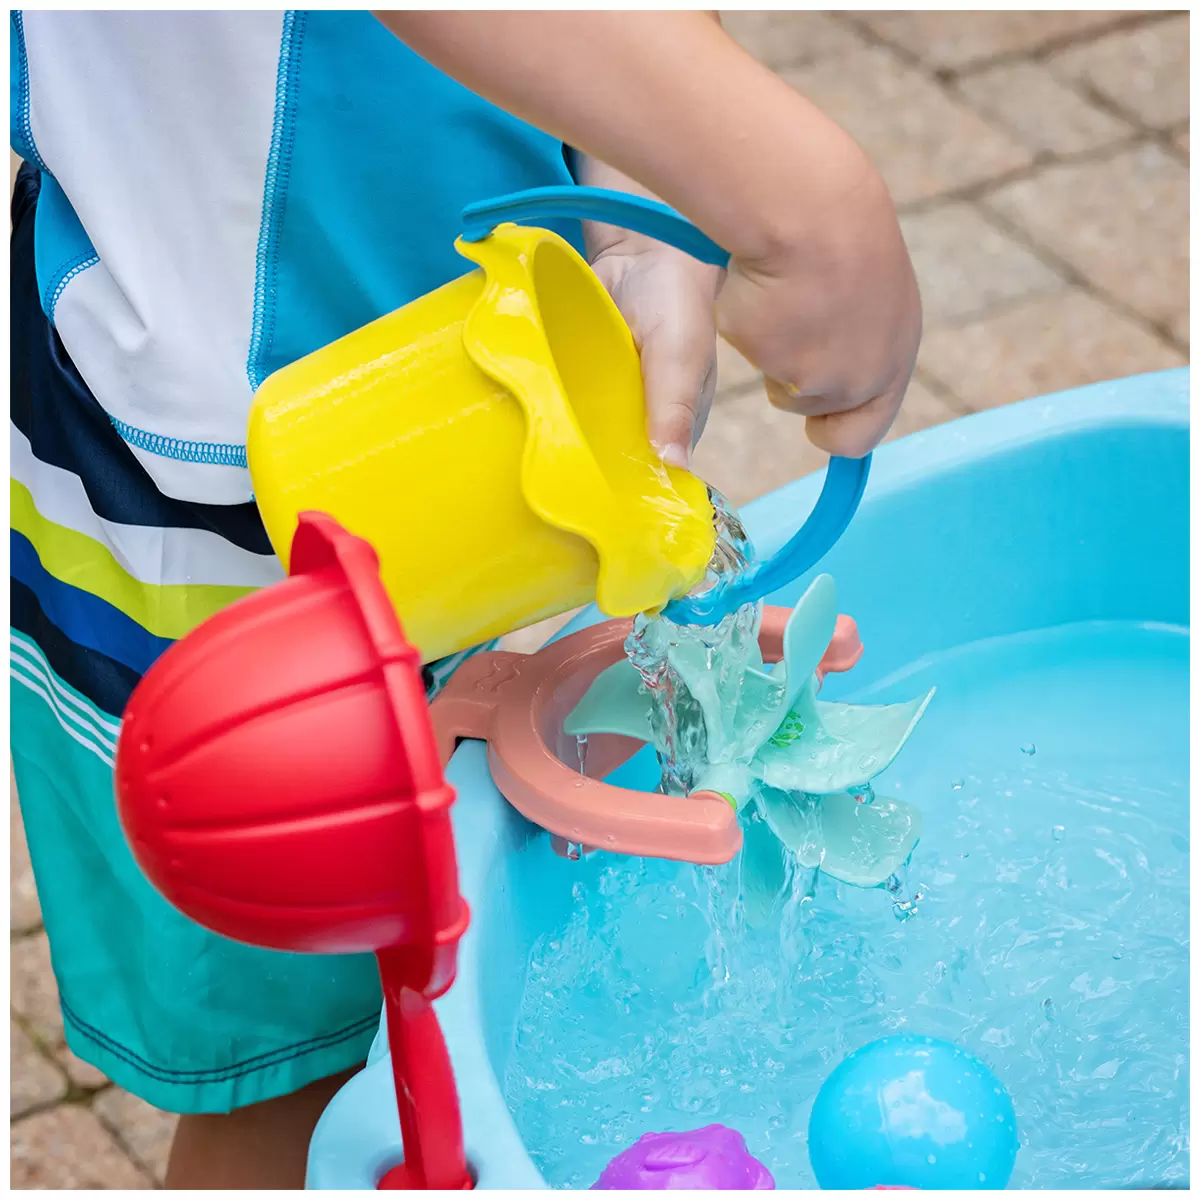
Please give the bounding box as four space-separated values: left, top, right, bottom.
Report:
462 186 871 625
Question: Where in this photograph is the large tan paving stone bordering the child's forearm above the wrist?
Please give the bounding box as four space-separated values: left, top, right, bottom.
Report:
780 47 1032 204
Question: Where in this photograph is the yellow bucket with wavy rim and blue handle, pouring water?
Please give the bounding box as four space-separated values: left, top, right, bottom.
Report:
247 187 868 662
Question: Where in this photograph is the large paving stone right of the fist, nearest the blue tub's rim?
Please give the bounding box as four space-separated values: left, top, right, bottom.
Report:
918 288 1184 409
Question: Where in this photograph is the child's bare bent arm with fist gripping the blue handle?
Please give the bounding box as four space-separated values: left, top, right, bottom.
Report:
379 11 920 455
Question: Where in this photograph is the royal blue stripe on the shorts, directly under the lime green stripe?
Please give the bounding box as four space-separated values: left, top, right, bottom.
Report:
8 529 170 674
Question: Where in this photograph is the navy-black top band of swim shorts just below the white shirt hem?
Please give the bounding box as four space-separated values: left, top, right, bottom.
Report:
8 166 272 554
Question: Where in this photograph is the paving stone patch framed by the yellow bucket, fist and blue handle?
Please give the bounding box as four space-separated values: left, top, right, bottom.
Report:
692 386 828 506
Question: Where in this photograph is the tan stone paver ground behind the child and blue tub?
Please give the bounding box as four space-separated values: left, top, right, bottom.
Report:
11 11 1190 1188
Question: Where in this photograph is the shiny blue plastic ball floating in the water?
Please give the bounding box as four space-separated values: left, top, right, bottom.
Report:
809 1034 1016 1190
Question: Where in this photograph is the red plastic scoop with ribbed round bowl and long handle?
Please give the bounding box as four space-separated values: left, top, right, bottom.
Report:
116 514 472 1190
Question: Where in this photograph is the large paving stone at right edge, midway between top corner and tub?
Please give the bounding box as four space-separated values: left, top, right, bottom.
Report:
984 143 1189 331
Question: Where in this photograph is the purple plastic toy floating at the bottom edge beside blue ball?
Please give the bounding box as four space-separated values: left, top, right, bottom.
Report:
592 1126 775 1192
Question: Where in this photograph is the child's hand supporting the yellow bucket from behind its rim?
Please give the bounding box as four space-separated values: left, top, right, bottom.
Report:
581 160 724 467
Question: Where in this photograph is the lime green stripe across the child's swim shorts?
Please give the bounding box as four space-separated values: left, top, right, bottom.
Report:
8 479 254 640
